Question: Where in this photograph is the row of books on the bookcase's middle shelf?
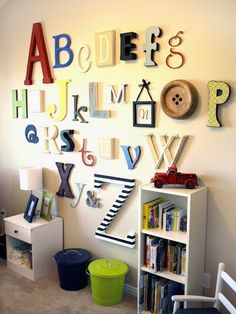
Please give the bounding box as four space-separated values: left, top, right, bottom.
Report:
144 235 186 276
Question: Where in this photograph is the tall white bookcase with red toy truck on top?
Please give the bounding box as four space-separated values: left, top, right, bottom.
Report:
138 184 207 313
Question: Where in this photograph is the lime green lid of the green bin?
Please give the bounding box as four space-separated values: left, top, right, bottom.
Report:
88 258 128 278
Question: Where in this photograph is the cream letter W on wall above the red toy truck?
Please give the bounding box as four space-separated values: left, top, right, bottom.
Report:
146 134 187 169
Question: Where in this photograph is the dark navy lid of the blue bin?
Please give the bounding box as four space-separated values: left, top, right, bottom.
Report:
55 248 92 265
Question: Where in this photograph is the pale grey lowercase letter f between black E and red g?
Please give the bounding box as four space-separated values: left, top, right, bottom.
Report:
143 26 162 67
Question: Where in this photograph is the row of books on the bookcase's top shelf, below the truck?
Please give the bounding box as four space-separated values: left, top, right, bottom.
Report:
143 198 187 231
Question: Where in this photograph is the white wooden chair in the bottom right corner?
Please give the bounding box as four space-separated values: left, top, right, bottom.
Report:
172 263 236 314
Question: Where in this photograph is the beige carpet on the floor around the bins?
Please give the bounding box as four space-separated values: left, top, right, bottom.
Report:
0 258 137 314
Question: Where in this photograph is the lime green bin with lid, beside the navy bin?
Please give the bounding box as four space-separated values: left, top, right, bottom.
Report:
88 258 128 305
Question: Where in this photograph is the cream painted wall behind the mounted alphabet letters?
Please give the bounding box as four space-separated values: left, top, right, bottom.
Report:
0 0 236 293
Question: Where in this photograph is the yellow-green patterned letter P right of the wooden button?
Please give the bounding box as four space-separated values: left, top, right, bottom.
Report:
207 81 230 128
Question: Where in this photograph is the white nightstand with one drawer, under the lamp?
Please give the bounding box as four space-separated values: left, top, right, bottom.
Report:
4 214 63 280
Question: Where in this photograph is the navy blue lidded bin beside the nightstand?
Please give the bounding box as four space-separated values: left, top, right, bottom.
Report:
55 248 92 291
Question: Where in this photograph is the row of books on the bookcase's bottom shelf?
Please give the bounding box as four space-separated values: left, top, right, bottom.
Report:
140 274 184 314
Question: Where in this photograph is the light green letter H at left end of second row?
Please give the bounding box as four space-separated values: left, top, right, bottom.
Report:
12 89 28 119
